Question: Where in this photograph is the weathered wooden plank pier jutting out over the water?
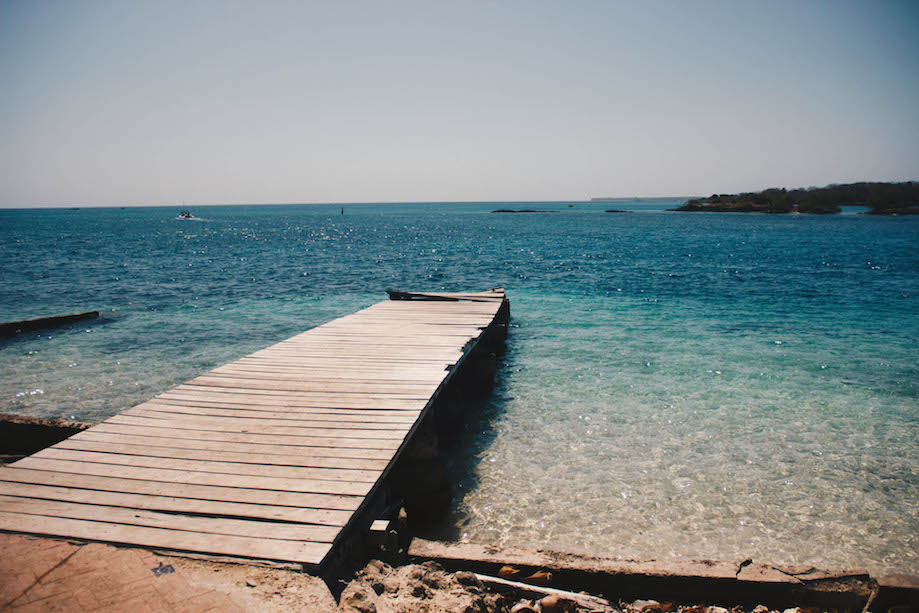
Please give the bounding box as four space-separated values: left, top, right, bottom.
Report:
0 290 508 572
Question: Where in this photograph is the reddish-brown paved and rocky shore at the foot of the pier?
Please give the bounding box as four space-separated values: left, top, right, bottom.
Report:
0 533 919 613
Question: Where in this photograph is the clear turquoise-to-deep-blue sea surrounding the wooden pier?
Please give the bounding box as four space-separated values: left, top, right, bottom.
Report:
0 201 919 574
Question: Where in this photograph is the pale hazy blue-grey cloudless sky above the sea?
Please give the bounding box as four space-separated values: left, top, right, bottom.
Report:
0 0 919 207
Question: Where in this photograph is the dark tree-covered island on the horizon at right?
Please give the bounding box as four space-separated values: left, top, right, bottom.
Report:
669 181 919 215
